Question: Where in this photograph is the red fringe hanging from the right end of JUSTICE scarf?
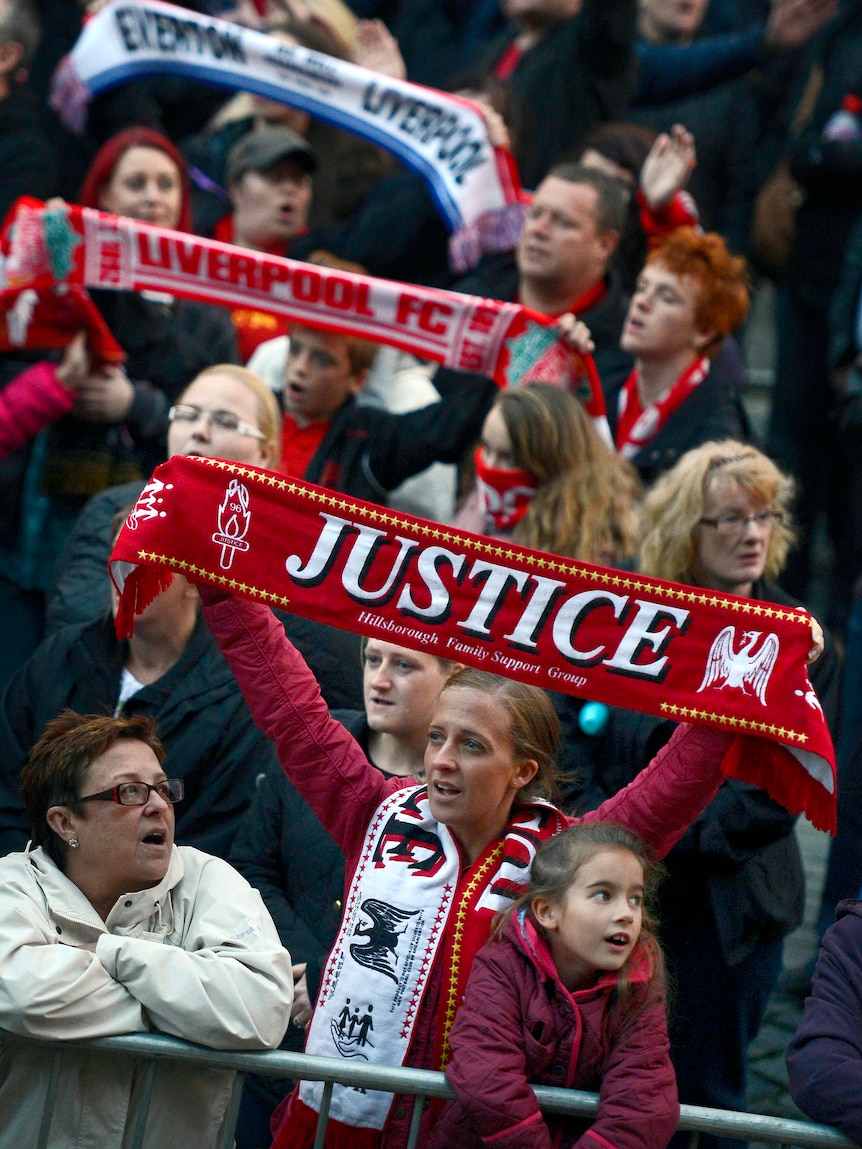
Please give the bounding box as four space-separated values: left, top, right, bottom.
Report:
722 734 837 835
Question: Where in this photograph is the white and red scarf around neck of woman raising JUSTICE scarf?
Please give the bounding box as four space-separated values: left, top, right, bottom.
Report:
299 786 565 1129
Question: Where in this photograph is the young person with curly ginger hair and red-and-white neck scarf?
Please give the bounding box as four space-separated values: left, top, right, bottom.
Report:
607 228 751 484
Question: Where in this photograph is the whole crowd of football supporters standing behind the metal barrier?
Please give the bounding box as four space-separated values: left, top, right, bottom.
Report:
0 0 862 1149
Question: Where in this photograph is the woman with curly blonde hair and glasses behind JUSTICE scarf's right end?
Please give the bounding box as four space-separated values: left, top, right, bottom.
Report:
570 440 839 1143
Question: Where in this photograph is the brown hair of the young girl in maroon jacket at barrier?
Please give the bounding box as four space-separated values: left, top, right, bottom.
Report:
492 822 667 1024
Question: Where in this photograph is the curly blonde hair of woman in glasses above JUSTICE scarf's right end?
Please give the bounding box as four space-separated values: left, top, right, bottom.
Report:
639 439 795 583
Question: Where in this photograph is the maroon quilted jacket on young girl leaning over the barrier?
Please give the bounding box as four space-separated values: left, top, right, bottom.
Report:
428 913 679 1149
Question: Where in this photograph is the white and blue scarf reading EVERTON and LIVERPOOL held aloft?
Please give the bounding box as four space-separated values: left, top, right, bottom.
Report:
51 0 525 271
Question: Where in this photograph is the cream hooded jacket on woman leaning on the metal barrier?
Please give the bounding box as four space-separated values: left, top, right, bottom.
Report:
0 846 293 1149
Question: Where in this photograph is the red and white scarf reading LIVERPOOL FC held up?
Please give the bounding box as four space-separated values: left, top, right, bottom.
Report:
0 198 605 404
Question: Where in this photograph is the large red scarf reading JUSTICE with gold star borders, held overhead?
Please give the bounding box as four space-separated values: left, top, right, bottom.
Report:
110 457 836 830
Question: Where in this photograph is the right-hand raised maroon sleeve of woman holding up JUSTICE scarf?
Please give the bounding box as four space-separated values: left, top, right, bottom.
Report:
583 724 734 858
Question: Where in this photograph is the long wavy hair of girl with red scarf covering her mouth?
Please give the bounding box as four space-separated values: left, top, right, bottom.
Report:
495 383 639 565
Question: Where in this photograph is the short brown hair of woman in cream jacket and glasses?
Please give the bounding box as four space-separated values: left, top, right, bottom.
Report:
21 710 164 870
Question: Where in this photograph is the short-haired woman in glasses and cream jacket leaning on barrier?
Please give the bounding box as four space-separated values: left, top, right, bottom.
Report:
0 711 293 1149
